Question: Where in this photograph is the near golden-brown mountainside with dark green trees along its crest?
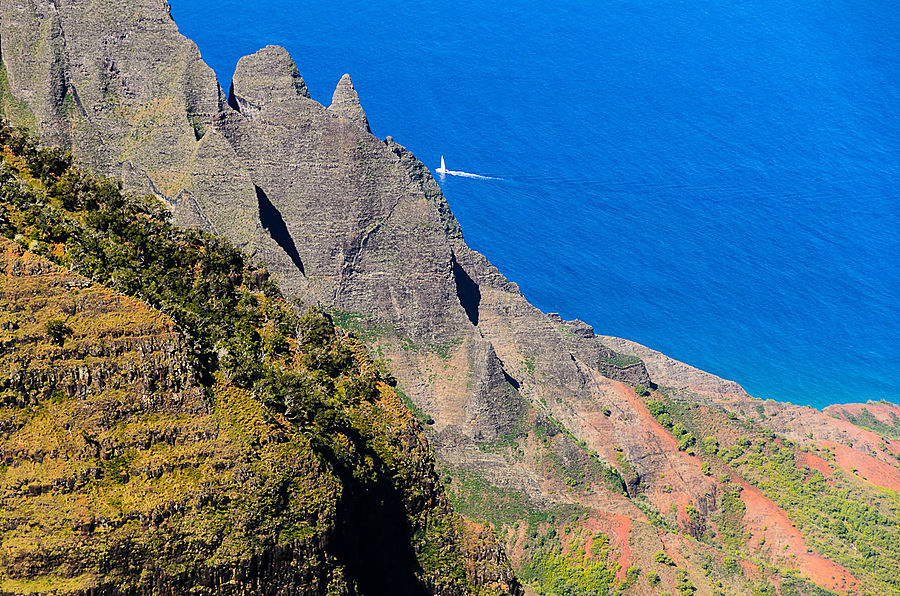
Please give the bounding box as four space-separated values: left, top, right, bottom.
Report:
0 128 518 594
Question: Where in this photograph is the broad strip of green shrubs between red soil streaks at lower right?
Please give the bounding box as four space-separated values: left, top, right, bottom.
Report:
647 388 900 594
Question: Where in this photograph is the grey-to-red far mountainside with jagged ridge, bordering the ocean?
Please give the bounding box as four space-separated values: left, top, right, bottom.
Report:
0 0 900 594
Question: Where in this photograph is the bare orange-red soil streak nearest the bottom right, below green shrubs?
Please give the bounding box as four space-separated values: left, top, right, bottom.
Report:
732 476 857 594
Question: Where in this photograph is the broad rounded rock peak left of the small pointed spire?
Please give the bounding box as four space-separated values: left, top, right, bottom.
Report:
228 45 309 116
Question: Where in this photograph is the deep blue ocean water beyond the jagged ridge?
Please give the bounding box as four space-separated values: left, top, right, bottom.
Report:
170 0 900 407
